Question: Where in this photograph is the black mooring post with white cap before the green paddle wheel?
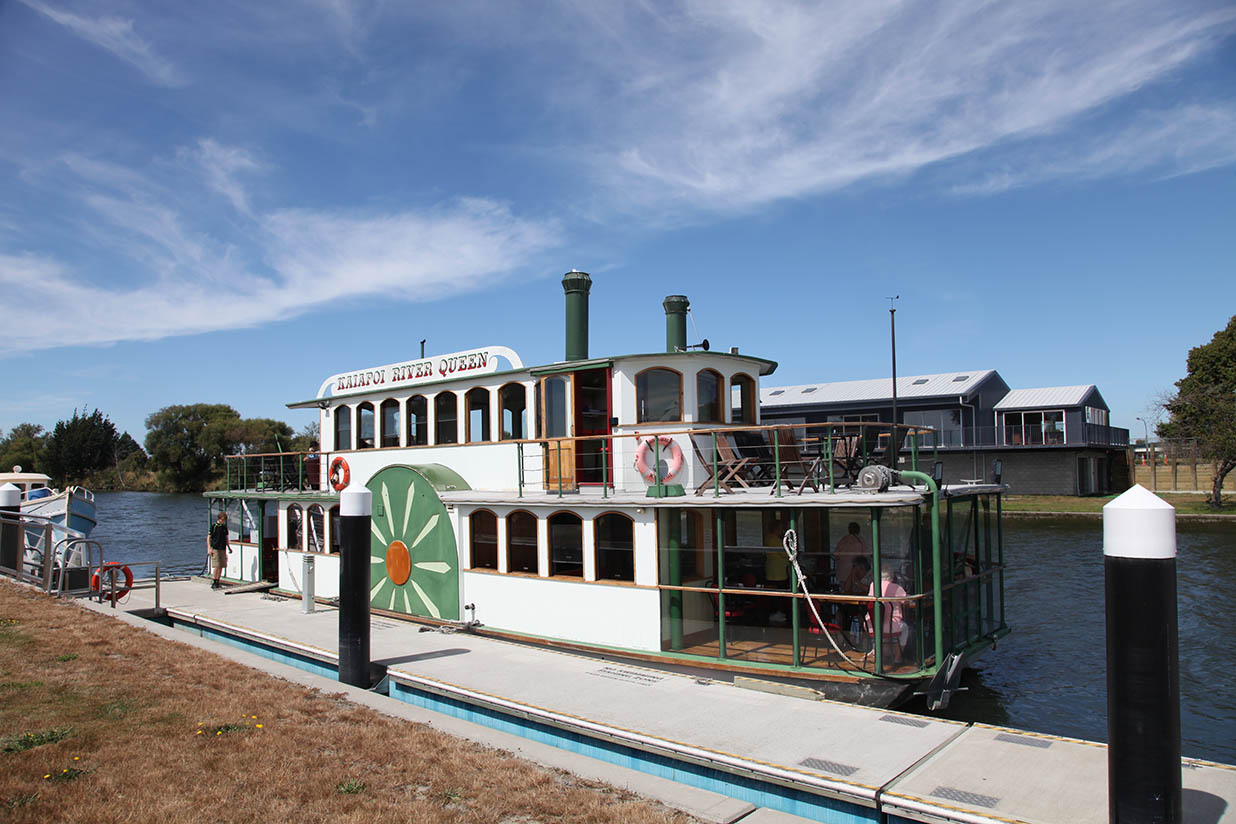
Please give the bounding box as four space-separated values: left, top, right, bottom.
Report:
339 486 373 689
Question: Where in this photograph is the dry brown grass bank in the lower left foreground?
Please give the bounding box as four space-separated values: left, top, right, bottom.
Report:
0 582 692 824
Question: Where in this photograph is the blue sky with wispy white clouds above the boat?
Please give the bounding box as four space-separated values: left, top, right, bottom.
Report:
0 0 1236 440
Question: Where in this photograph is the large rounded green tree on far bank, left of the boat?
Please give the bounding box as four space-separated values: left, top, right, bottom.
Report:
146 404 242 492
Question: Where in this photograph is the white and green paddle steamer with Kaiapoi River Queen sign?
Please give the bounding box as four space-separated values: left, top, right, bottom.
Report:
206 271 1009 705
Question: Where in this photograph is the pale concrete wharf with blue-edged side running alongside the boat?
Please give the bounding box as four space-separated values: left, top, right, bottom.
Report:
95 579 1236 824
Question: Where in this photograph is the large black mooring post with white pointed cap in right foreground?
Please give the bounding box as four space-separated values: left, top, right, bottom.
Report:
1103 484 1184 824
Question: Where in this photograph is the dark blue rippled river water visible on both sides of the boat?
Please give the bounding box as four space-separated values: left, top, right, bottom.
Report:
93 492 1236 763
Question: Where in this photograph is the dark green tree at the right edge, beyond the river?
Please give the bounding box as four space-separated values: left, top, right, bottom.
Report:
1158 316 1236 508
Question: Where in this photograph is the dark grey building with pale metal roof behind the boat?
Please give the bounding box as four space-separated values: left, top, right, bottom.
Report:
760 369 1128 495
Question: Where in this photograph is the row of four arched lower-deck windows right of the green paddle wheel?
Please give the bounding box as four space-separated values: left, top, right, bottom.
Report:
468 509 635 582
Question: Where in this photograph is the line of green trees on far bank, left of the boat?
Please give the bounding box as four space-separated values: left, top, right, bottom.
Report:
0 404 318 492
